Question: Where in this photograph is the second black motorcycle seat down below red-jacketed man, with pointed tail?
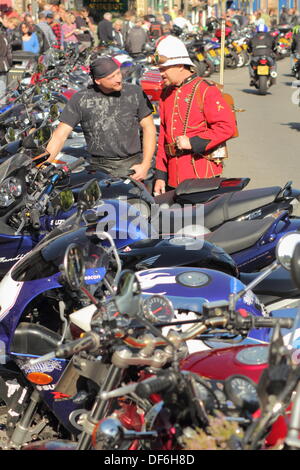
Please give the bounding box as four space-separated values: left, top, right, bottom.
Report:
204 186 281 229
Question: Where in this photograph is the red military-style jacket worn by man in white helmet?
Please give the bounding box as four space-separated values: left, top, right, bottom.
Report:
155 74 236 187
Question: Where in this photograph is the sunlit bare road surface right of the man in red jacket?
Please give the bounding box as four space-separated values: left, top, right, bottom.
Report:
218 58 300 189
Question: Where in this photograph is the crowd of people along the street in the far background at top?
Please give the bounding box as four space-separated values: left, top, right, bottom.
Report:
0 3 300 63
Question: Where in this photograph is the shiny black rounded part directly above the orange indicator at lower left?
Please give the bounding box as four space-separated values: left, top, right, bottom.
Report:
11 322 61 356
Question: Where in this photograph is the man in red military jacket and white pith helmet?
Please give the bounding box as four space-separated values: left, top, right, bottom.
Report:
154 36 236 195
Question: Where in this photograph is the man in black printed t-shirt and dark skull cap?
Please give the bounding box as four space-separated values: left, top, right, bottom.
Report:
47 56 156 181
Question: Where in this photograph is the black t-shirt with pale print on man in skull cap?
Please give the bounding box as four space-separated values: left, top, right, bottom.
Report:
60 83 153 158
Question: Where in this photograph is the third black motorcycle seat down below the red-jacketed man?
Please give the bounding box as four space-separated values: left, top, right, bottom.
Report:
205 217 274 255
